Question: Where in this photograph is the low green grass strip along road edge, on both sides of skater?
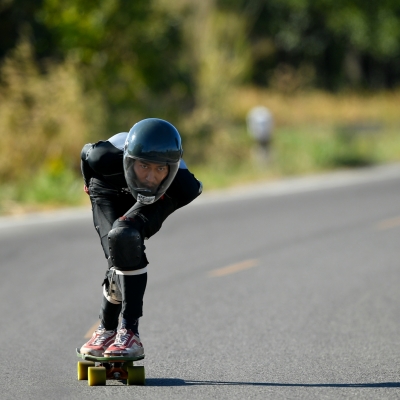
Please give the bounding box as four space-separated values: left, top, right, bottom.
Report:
0 125 400 214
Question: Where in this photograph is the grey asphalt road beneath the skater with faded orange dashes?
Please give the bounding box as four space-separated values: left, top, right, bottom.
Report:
0 166 400 400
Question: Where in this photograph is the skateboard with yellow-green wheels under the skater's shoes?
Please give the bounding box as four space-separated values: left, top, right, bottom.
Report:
76 349 145 386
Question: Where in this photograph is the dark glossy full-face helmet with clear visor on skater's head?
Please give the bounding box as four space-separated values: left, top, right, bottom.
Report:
124 118 183 204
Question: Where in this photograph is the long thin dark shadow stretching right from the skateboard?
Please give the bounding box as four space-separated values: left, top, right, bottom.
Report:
146 378 400 389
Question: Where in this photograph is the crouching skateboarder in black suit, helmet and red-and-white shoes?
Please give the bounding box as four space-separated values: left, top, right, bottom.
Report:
80 118 202 357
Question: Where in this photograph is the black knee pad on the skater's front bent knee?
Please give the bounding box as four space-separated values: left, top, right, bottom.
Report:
108 219 146 271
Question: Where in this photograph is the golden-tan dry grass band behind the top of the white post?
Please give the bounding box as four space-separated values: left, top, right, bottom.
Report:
232 88 400 126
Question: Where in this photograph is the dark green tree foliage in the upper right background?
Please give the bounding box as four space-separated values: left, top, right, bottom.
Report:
218 0 400 89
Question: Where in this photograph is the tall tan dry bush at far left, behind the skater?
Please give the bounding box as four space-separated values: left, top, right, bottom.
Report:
0 39 104 183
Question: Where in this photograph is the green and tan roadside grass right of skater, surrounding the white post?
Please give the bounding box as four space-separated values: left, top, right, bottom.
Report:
192 87 400 189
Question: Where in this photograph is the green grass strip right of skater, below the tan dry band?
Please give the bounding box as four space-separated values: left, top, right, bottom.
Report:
191 124 400 190
